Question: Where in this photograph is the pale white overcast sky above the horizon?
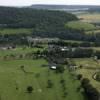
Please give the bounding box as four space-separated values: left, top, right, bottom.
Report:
0 0 100 6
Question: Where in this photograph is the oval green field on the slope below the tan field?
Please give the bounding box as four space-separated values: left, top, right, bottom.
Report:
65 21 96 31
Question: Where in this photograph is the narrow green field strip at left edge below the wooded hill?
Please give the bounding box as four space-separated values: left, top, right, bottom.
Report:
0 28 32 34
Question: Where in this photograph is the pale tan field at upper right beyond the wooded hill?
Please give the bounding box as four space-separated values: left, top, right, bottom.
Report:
77 13 100 23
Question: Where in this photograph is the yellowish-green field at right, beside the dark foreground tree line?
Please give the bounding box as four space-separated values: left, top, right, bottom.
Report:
73 58 100 91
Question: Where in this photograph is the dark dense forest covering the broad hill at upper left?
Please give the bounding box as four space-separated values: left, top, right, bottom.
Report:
0 7 77 28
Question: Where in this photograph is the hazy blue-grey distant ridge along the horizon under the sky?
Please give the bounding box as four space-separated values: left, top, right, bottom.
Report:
30 4 100 11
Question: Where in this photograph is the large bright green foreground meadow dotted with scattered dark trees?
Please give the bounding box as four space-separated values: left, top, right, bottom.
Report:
0 59 84 100
